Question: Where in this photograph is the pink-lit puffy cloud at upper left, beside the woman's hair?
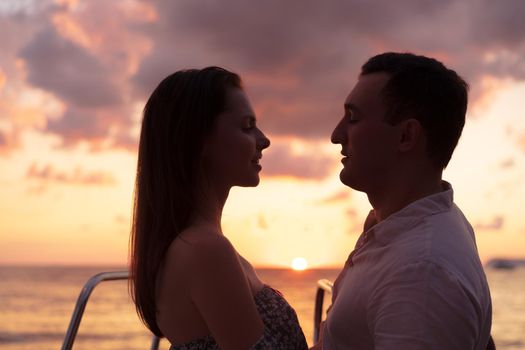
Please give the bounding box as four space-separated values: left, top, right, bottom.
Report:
8 2 149 150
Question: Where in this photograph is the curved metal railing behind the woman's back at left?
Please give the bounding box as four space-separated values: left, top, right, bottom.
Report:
62 271 160 350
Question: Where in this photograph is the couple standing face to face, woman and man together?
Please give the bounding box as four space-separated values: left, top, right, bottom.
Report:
131 53 492 350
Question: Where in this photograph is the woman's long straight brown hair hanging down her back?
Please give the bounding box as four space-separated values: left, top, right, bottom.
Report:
129 67 241 337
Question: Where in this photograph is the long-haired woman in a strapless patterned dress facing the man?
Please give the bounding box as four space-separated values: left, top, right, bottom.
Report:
131 67 307 349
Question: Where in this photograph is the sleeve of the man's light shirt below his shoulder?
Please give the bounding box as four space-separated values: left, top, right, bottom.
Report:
367 262 480 350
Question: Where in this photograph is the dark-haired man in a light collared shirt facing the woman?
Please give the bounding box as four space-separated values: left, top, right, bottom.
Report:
322 53 492 350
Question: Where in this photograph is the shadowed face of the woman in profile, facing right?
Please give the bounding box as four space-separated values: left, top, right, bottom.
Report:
202 88 270 189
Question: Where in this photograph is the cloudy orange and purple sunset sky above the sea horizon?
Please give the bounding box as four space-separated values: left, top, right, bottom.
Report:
0 0 525 267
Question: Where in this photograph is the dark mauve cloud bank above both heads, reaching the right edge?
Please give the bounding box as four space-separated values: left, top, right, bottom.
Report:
130 0 525 144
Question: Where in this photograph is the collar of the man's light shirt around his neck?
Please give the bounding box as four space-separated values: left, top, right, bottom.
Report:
364 181 454 245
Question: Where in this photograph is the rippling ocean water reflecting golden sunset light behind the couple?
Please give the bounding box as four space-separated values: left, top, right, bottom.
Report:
0 266 525 350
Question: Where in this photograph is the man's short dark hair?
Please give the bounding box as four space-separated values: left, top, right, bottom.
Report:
361 52 468 169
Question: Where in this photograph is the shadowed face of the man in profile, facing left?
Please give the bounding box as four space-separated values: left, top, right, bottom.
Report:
332 73 400 194
